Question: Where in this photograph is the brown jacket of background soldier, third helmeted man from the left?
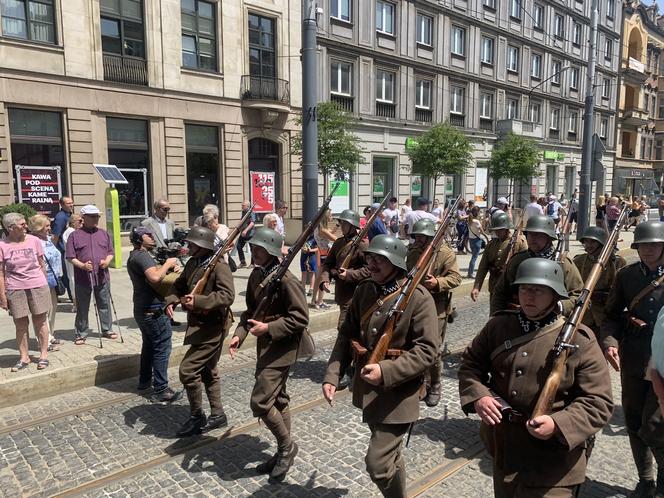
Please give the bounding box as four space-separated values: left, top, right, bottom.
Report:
320 237 371 305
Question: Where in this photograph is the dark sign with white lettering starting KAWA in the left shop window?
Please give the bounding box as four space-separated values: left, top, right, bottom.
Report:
16 165 62 218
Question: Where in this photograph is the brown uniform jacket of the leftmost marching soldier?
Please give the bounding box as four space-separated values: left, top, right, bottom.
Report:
165 258 235 344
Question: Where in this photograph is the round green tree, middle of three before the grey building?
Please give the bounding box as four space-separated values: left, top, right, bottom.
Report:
406 123 473 196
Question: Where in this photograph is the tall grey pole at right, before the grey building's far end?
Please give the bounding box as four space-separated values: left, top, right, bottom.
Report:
577 0 597 239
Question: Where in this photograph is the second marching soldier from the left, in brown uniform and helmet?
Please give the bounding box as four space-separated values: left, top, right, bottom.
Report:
229 228 309 481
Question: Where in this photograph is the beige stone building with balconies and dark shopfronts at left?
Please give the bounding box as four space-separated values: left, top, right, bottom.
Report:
0 0 301 230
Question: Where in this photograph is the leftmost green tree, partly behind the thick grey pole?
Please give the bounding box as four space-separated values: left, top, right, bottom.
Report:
291 102 365 192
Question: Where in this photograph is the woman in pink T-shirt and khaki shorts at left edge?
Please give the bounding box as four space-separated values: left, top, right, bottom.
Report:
0 213 51 372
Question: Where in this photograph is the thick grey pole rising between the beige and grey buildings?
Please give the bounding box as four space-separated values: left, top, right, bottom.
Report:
302 0 318 227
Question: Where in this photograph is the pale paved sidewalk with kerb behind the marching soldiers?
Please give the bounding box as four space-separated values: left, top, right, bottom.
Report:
0 232 633 407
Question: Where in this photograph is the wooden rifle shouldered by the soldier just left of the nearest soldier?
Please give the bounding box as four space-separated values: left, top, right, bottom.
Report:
368 196 461 364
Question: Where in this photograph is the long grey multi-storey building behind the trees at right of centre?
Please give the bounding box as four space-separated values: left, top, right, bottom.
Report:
318 0 622 207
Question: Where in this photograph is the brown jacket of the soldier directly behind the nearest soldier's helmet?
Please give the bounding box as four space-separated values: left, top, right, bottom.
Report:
490 251 583 315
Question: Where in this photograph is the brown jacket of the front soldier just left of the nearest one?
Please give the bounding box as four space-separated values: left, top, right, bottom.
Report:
323 280 439 424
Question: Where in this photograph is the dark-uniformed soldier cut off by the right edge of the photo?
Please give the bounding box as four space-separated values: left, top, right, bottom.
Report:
600 221 664 498
